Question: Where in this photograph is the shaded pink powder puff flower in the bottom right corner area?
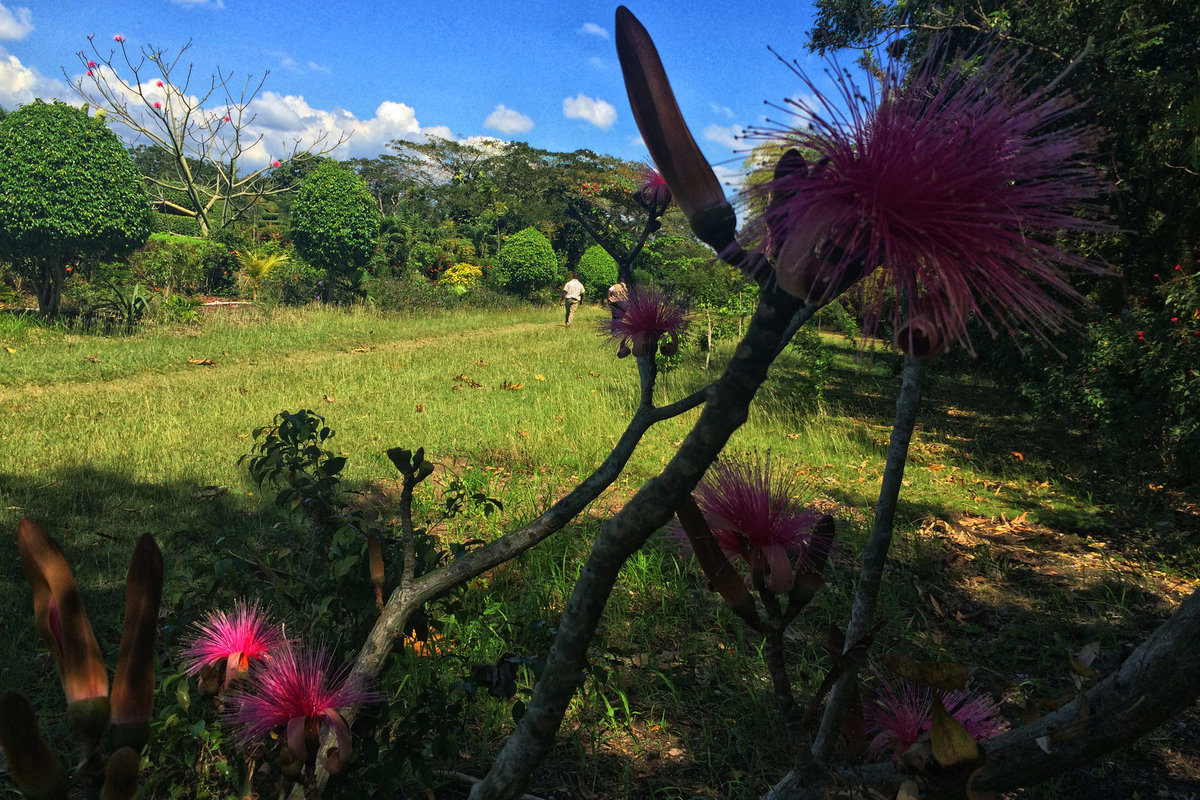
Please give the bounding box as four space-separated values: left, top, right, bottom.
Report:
863 678 1008 758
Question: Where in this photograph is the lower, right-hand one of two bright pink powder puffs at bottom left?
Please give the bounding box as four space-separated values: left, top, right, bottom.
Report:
227 643 377 772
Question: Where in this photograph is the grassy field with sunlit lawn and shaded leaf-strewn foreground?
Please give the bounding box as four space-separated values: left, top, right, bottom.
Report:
0 303 1200 799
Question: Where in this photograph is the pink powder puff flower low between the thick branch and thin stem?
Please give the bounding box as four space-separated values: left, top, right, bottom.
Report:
695 458 832 594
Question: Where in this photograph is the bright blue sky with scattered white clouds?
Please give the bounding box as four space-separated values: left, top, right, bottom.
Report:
0 0 824 189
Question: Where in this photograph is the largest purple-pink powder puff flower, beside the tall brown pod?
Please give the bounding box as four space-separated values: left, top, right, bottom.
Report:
755 38 1111 356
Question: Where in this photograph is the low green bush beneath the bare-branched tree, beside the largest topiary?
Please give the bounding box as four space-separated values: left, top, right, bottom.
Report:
130 233 238 294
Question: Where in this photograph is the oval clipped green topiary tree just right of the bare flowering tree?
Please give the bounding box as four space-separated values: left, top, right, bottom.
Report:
292 161 379 297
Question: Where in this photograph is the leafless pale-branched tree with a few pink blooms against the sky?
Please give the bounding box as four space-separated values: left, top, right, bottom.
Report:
72 36 346 236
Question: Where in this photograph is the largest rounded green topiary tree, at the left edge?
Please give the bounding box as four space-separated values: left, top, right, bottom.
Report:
0 100 150 317
